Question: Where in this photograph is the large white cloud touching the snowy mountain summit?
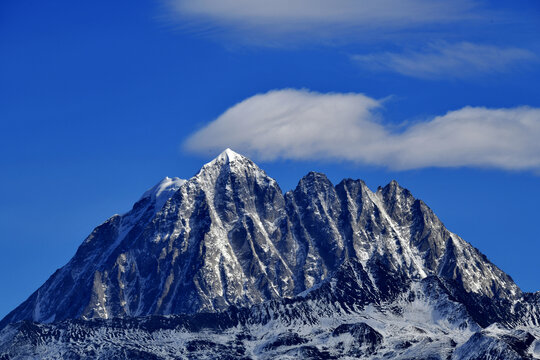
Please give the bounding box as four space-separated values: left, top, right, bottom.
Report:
184 89 540 171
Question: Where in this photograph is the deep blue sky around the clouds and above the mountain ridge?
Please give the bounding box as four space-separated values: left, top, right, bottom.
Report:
0 0 540 317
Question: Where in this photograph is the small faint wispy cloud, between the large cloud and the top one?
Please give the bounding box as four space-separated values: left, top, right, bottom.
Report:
353 42 537 78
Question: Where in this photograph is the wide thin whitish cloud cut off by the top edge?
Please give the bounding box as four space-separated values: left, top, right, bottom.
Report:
166 0 477 41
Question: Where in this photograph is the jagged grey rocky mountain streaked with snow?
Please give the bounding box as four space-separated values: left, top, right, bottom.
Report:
0 149 540 358
